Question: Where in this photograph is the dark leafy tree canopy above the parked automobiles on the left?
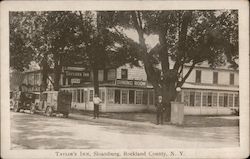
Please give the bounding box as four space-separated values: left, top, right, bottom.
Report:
10 11 141 91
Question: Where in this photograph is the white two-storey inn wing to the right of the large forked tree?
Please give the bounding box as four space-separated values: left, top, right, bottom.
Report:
174 65 239 114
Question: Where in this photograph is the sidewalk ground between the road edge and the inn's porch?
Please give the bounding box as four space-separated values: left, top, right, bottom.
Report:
69 110 239 127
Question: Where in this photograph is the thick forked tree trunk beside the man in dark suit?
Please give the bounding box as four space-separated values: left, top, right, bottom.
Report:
132 12 178 121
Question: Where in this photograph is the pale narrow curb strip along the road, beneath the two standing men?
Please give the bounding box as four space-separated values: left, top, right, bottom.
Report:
69 113 173 128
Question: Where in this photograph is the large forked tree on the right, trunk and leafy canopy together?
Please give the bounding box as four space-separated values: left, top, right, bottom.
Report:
99 10 239 120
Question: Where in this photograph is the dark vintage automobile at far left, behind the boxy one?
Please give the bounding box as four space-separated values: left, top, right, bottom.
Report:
11 91 37 113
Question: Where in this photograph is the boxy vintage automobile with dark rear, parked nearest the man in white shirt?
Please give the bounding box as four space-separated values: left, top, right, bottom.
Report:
34 91 72 117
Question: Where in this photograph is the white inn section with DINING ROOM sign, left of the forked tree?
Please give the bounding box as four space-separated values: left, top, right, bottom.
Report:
61 65 154 112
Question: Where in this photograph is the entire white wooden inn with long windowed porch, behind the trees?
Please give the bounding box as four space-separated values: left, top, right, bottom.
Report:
18 64 239 115
